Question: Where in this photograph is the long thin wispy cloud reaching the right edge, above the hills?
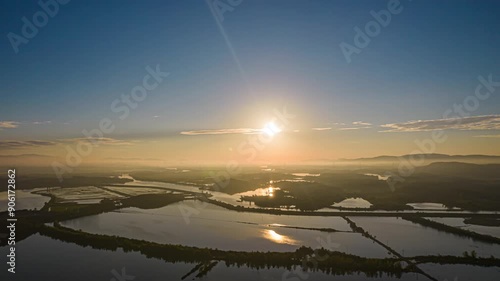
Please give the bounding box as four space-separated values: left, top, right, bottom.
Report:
381 115 500 132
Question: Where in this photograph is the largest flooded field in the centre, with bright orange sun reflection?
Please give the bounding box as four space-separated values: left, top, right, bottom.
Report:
62 200 388 257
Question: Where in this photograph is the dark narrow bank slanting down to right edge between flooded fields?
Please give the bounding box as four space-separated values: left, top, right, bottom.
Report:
402 216 500 244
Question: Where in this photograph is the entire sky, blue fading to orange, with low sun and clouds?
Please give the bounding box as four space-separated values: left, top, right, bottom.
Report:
0 0 500 163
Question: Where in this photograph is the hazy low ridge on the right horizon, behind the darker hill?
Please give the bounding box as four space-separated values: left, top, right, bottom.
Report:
336 153 500 165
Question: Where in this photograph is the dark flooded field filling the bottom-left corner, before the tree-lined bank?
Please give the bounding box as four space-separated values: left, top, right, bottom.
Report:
0 234 196 281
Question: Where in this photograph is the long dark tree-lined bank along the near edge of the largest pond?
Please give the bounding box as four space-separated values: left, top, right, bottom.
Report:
39 223 406 277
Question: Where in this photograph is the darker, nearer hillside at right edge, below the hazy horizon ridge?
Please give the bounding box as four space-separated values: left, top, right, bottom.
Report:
416 162 500 179
